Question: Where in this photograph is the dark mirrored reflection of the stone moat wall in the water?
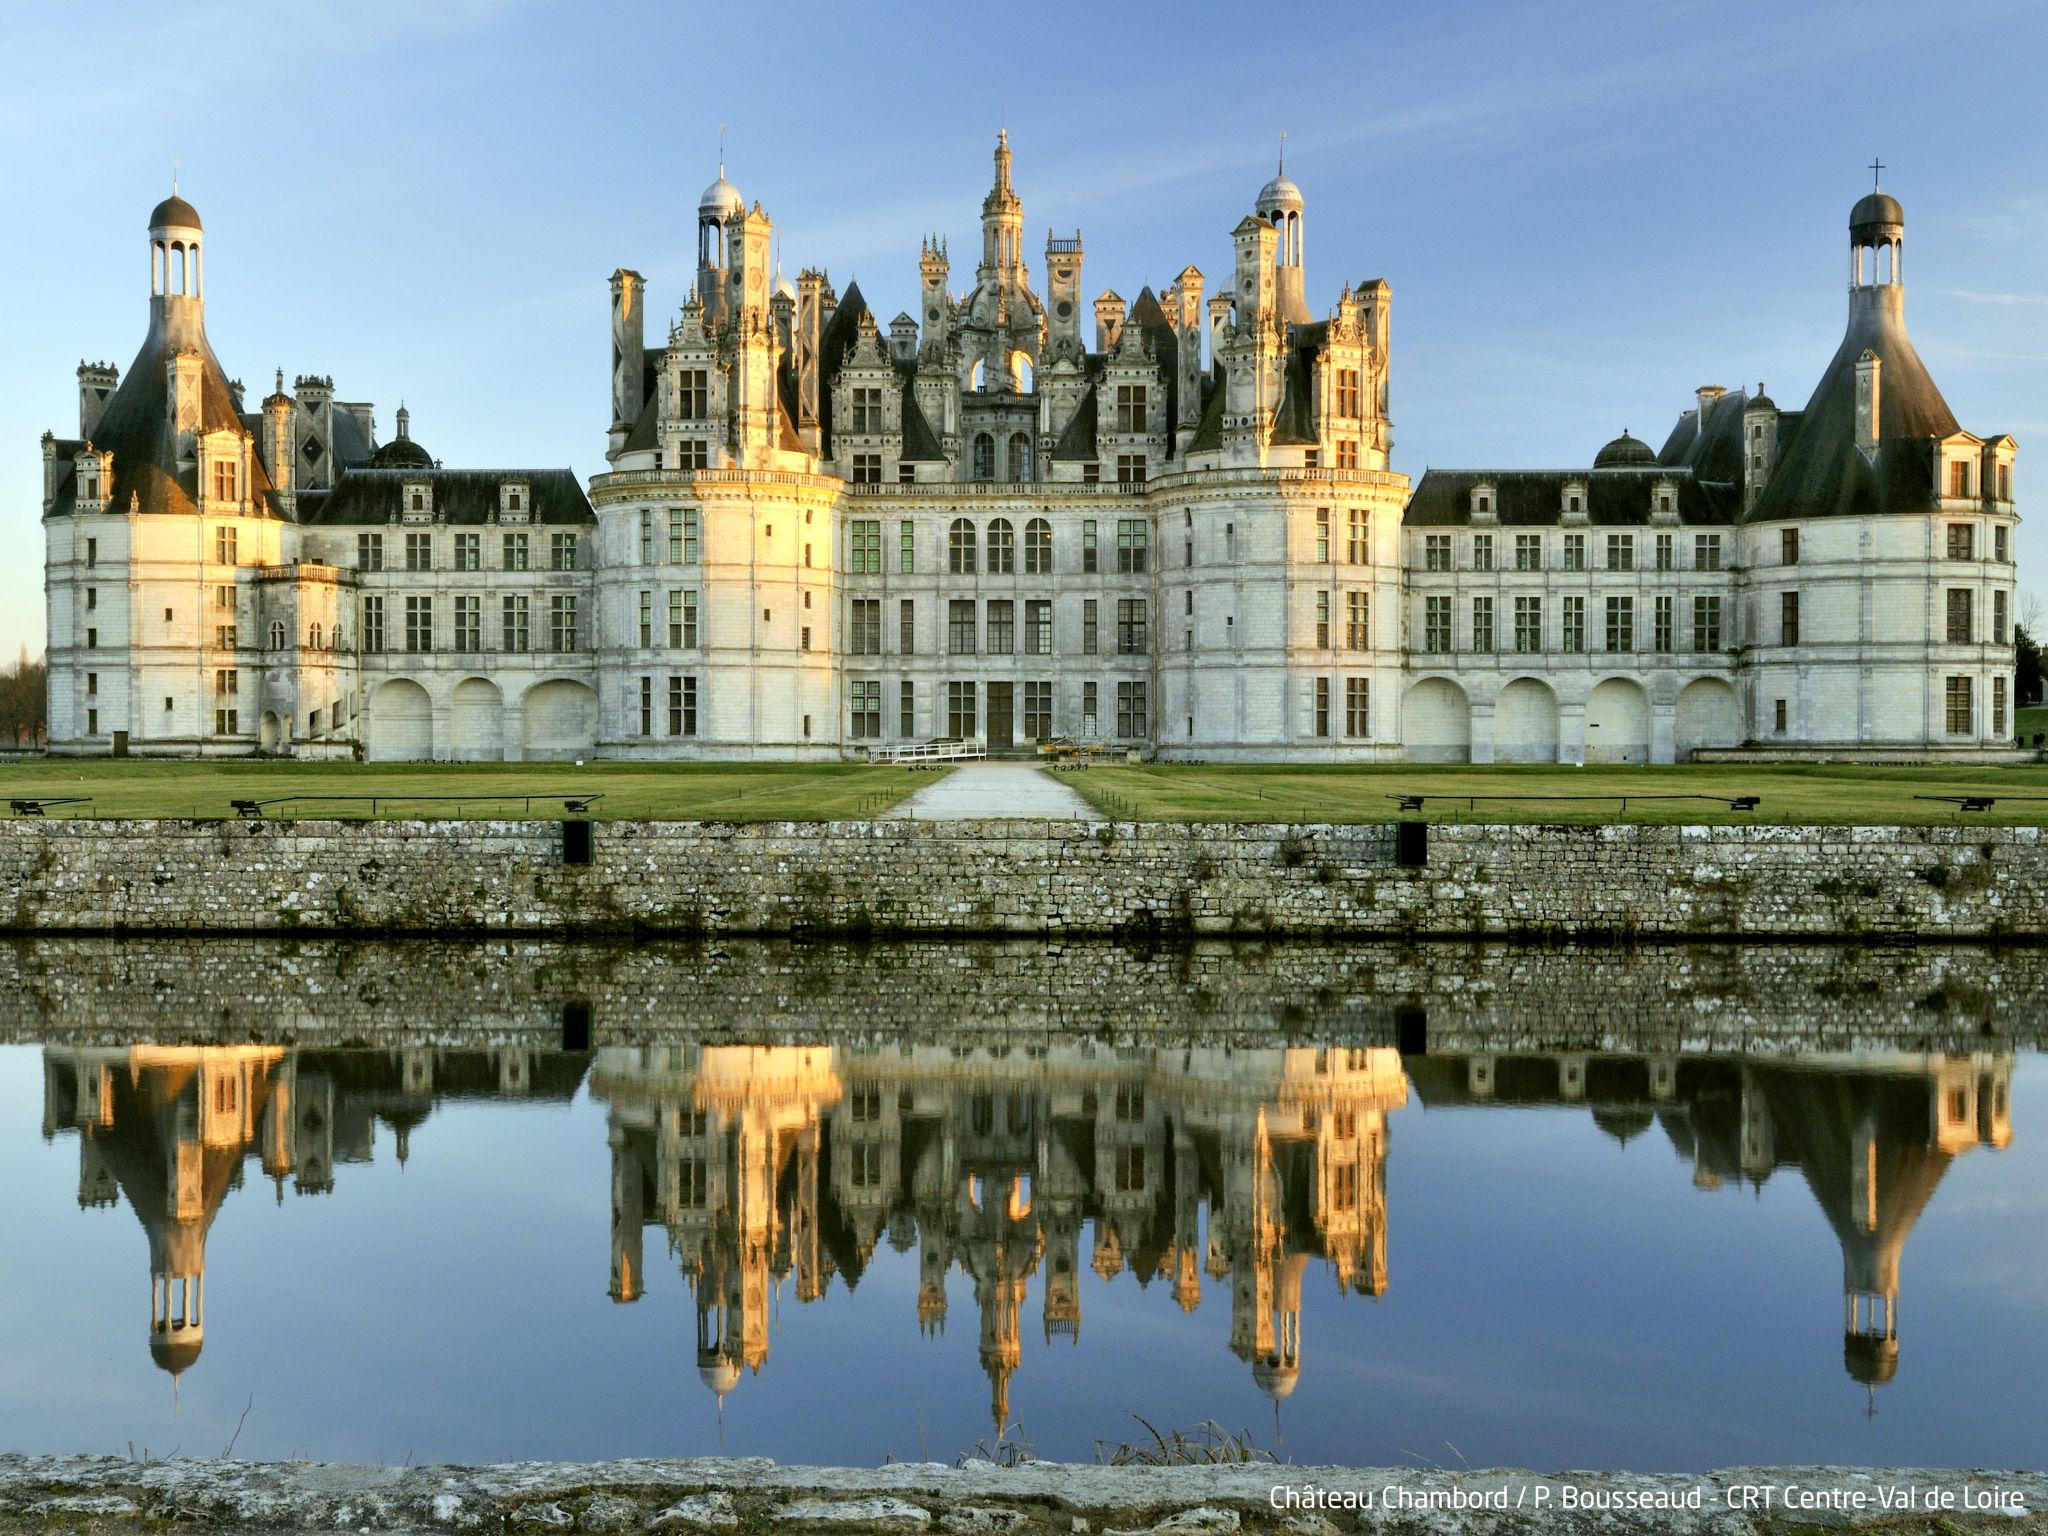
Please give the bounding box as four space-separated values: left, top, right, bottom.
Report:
0 936 2048 1053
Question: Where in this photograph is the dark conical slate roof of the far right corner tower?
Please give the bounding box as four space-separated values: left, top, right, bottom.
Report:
1745 287 1962 522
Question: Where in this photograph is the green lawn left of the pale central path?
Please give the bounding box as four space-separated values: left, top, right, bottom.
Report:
0 758 932 821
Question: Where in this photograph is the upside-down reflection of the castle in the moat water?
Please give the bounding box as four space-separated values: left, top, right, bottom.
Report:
43 1042 2011 1423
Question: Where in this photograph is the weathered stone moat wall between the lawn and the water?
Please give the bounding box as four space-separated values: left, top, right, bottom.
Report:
0 819 2048 938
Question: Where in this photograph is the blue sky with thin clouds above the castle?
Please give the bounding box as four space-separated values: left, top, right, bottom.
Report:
0 0 2048 655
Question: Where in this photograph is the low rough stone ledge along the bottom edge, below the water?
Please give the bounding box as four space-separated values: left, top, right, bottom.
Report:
0 1456 2048 1536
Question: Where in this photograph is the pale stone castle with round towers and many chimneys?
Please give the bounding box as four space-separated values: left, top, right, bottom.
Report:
43 137 2017 762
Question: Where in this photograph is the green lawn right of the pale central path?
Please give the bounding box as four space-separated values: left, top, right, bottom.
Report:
1061 764 2048 825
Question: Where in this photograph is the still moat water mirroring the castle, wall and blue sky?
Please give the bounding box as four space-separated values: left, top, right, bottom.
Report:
0 942 2048 1468
